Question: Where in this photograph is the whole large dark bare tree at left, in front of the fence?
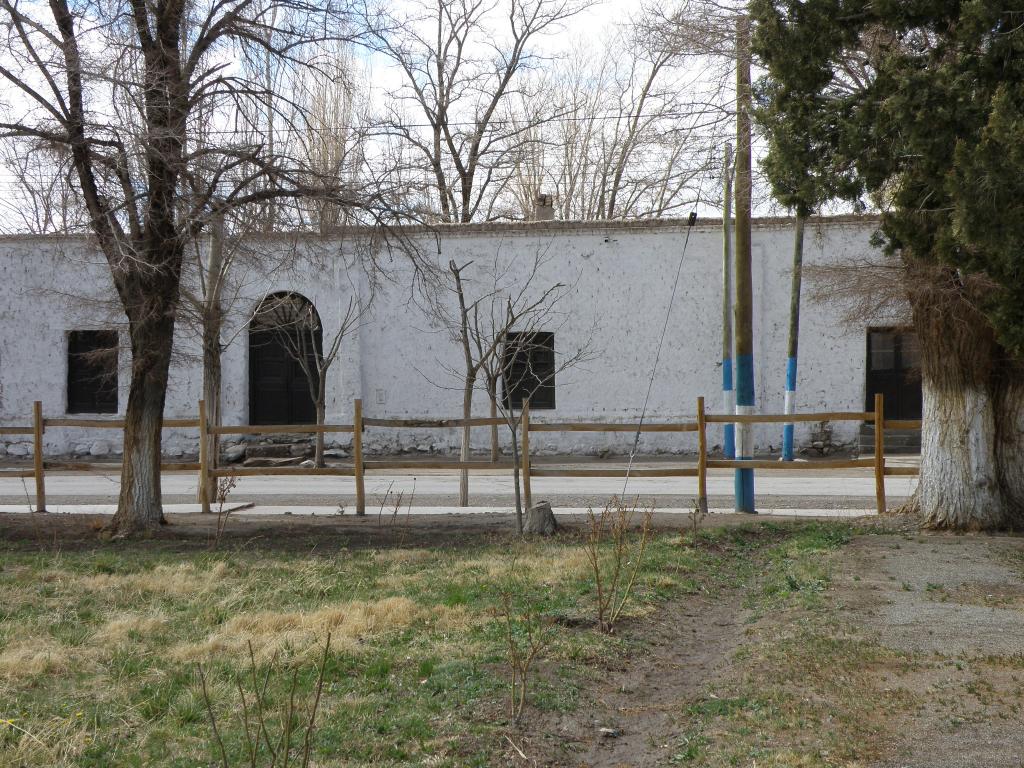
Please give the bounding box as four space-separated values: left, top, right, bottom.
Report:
0 0 399 532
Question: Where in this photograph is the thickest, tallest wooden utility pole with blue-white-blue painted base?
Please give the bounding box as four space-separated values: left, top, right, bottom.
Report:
735 15 755 513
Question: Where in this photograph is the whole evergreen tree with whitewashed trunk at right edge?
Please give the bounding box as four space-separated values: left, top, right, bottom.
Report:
751 0 1024 528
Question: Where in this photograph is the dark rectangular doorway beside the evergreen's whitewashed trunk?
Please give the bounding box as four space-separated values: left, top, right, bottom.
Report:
864 328 921 419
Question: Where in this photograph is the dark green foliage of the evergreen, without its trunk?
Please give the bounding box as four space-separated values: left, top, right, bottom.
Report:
751 0 1024 348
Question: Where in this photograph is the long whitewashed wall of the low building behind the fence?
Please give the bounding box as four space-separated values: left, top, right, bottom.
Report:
0 217 912 456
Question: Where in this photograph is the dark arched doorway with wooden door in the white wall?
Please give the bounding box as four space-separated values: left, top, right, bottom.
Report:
249 292 324 424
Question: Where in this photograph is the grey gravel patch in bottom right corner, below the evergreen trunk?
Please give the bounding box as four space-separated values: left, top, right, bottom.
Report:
836 535 1024 768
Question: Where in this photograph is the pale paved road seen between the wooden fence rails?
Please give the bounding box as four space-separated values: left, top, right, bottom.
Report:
0 460 916 510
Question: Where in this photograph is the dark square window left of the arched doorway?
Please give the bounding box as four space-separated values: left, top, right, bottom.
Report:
68 331 118 414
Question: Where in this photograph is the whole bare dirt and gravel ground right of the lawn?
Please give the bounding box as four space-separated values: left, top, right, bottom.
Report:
524 531 1024 768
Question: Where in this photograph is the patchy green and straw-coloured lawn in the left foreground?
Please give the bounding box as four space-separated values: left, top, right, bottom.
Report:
0 522 849 768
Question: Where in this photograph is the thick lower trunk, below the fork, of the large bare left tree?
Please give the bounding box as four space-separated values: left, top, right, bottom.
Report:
111 307 174 535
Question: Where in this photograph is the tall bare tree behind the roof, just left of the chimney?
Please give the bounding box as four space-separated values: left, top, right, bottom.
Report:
362 0 594 222
